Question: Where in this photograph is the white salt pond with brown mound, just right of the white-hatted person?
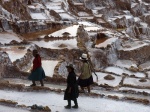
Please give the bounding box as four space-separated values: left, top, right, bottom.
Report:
93 72 122 87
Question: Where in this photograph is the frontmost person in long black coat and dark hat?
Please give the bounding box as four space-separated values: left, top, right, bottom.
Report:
64 64 79 109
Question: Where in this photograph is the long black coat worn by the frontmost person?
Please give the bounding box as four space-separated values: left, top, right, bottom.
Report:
64 71 79 100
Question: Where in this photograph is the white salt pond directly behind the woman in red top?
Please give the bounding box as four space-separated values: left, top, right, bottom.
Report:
42 60 59 77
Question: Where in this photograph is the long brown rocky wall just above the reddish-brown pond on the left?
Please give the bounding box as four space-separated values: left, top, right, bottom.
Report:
0 18 63 34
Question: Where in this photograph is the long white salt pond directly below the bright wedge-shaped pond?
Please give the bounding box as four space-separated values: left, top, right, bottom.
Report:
32 38 78 49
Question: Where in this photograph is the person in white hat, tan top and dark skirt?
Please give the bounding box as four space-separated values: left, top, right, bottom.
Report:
78 54 93 93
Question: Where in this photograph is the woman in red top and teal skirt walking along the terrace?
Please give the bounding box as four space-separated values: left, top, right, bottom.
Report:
28 50 45 86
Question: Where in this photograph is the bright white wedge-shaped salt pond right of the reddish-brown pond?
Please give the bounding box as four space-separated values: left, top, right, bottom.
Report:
49 25 79 37
